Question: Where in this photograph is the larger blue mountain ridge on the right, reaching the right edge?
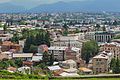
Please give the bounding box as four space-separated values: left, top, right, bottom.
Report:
30 0 120 12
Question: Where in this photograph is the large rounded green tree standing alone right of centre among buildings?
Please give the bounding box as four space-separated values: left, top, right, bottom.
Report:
81 40 99 63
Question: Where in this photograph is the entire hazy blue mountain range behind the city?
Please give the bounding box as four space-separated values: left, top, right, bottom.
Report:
0 0 120 13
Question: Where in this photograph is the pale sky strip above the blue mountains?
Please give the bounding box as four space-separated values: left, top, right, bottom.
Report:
0 0 91 8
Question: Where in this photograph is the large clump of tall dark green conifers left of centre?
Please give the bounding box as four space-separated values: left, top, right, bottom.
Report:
23 30 50 53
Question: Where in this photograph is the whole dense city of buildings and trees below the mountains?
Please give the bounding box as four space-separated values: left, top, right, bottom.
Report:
0 12 120 80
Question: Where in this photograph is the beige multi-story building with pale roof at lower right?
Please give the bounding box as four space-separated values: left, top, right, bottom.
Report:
92 51 113 74
